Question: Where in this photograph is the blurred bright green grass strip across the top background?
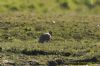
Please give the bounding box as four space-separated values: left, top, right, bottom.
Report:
0 0 100 14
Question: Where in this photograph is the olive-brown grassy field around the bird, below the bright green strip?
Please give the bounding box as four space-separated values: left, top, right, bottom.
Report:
0 12 100 66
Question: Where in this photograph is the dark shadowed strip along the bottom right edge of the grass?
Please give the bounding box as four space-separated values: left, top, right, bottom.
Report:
48 57 99 66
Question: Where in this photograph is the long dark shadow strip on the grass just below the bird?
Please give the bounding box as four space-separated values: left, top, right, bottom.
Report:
22 49 71 56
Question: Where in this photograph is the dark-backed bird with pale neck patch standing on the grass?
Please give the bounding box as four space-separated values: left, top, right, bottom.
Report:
39 31 52 43
